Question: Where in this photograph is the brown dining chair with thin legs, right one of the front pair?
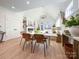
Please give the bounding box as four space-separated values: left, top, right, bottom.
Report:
33 34 47 56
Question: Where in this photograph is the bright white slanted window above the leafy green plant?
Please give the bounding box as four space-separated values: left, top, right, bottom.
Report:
65 0 79 18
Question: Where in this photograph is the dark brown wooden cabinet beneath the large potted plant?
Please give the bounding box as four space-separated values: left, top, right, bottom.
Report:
62 34 79 59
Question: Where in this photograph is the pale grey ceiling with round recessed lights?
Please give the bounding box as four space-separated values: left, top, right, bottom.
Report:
0 0 71 12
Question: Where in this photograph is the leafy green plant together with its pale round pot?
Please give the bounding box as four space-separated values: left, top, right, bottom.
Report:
64 14 79 37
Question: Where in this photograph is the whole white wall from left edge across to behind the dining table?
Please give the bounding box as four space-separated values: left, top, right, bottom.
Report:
0 6 58 41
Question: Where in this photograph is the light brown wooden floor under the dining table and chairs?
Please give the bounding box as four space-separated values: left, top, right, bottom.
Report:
0 39 67 59
